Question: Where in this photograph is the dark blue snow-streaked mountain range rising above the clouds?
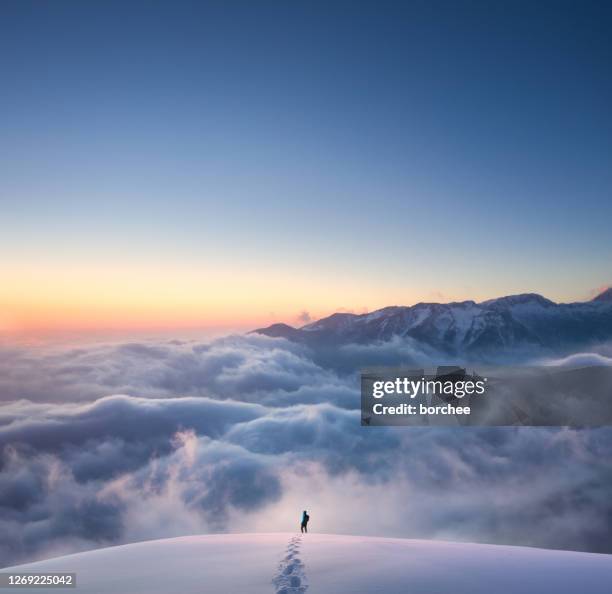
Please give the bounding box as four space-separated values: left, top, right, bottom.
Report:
255 288 612 357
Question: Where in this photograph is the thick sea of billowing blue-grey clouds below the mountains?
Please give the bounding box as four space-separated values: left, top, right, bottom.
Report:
0 334 612 566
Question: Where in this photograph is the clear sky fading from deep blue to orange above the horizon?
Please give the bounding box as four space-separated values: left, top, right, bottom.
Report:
0 0 612 330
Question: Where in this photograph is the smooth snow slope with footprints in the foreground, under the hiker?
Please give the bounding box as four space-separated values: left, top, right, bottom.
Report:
2 533 612 594
